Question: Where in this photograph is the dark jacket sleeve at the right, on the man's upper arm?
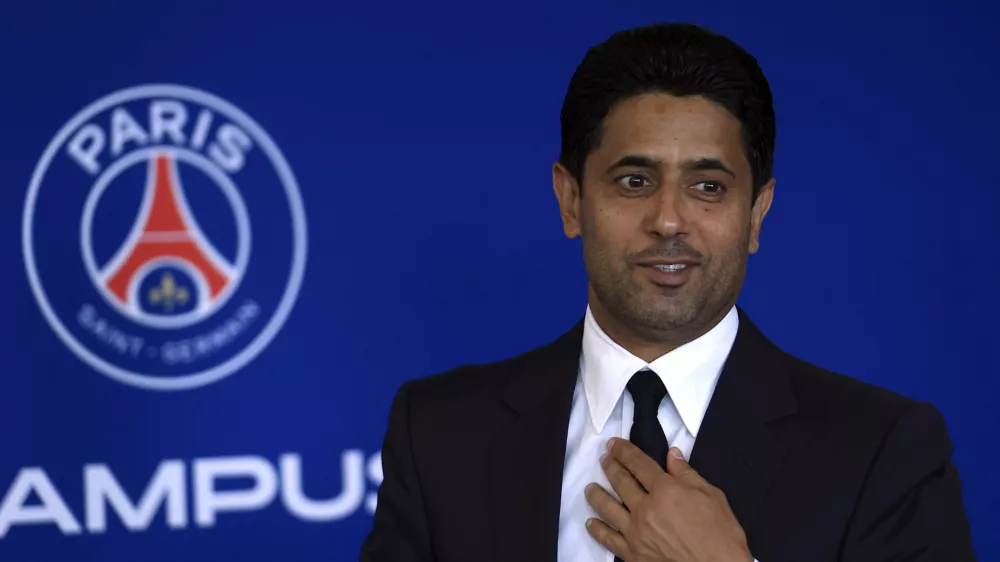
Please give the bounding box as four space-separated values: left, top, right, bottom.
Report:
840 402 976 562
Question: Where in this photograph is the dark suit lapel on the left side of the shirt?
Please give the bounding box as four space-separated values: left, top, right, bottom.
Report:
489 322 583 562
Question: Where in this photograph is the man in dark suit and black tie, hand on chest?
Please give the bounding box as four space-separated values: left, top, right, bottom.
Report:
361 24 975 562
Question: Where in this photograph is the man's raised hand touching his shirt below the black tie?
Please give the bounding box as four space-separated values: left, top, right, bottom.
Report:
586 438 753 562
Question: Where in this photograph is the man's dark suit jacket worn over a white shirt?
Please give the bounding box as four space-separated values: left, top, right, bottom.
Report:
361 311 975 562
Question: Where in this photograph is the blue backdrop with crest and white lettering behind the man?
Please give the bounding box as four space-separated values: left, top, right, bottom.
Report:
0 0 1000 562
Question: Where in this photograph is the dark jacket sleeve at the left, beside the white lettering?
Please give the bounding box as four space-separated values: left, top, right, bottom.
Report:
361 382 434 562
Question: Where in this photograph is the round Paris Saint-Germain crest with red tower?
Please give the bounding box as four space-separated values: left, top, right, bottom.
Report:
22 85 306 390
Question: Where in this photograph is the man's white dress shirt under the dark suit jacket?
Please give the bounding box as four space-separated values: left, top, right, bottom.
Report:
559 307 752 562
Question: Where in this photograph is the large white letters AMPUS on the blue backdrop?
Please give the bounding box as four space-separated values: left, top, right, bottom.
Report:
0 449 382 540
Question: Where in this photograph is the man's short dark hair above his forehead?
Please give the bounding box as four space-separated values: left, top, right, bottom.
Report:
559 23 776 200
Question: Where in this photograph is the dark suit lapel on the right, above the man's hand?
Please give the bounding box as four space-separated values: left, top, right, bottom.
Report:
691 310 796 535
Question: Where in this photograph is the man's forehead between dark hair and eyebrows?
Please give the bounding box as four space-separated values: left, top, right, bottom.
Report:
588 93 749 173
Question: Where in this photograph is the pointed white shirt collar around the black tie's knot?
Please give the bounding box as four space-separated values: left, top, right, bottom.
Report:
580 306 739 437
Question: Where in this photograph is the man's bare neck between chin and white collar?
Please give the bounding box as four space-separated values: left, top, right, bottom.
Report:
589 290 733 363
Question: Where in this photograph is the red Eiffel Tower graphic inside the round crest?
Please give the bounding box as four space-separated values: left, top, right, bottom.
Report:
105 154 231 304
